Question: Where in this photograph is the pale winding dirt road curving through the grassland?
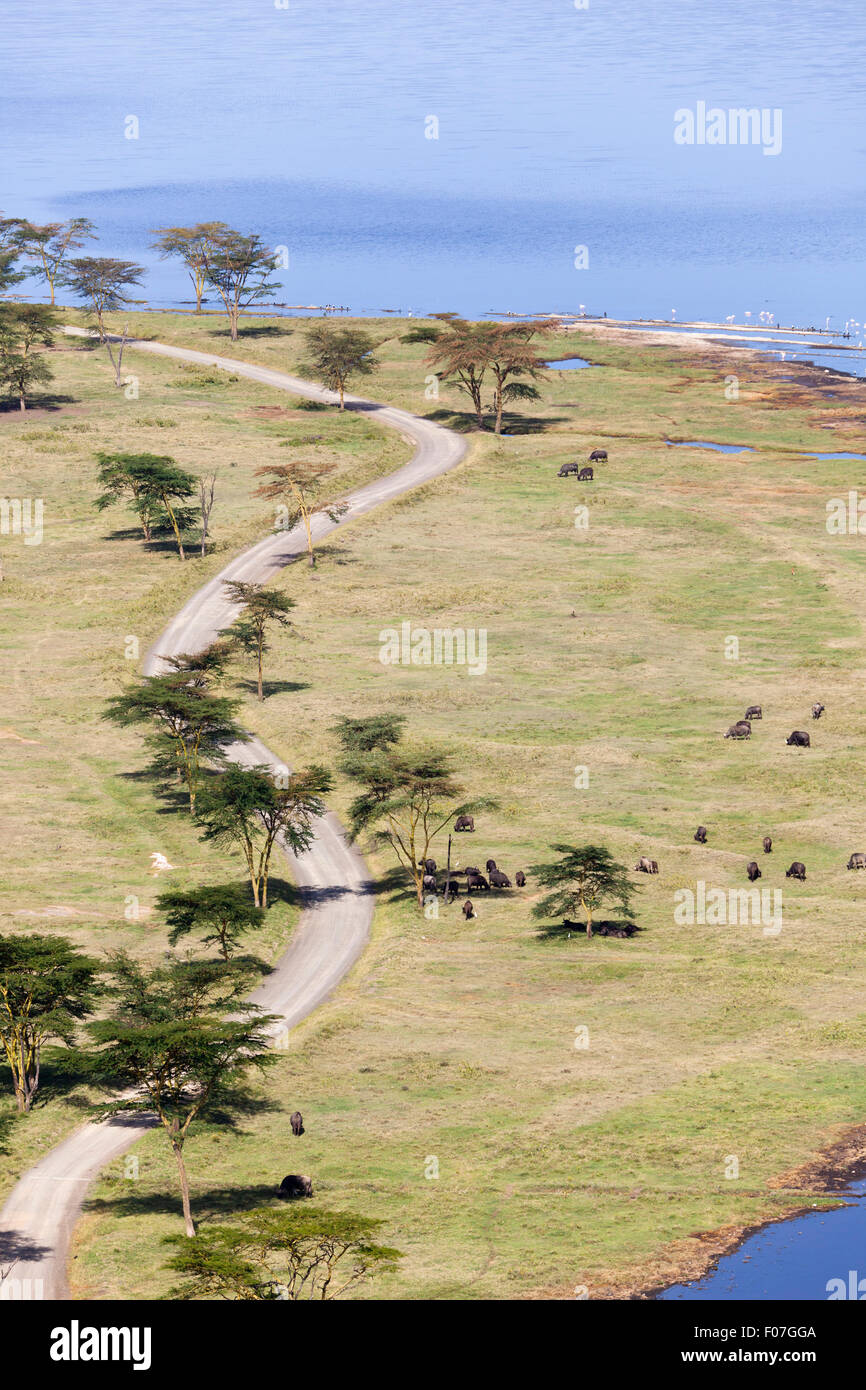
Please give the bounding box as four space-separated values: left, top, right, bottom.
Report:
0 329 466 1300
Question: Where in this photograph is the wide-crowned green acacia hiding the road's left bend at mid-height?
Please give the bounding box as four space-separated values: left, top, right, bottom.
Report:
104 670 249 816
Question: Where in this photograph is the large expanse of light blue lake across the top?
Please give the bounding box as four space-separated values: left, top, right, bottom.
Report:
0 0 866 329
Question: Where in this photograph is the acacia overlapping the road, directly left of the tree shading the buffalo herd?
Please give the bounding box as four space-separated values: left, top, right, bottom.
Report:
196 763 331 908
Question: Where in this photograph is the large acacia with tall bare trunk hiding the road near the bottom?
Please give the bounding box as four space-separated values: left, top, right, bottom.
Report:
82 955 277 1237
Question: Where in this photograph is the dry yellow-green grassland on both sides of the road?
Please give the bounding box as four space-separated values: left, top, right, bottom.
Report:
3 316 866 1298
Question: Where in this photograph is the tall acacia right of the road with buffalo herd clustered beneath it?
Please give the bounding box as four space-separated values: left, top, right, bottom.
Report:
338 716 495 908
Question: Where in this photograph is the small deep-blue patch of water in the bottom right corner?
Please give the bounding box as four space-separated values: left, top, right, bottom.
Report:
657 1180 866 1301
